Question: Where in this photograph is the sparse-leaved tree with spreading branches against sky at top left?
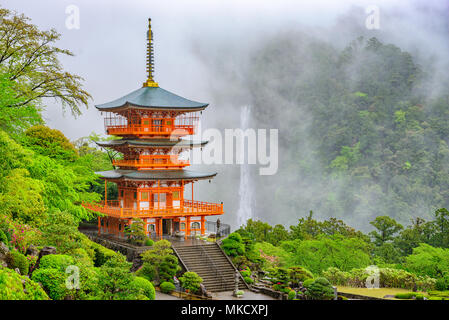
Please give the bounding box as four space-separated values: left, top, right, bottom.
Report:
0 8 90 115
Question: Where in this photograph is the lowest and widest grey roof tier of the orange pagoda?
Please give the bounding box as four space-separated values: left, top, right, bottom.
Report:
95 169 217 181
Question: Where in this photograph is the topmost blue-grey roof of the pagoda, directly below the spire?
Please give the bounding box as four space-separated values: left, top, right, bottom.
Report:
95 87 209 111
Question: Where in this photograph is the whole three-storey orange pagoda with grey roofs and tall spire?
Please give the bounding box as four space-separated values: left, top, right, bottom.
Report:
84 19 223 237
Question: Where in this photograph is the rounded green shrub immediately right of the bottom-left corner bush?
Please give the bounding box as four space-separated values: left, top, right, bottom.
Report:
32 268 70 300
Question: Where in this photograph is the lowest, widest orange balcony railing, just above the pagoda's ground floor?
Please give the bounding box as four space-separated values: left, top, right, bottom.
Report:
83 200 223 218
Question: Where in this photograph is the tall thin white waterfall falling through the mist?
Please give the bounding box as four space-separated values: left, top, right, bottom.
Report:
237 106 253 227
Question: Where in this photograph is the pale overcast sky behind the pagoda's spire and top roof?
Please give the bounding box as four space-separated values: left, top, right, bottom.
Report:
1 0 441 140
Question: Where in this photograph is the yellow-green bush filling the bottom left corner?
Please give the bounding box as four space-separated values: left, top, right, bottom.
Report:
0 268 49 300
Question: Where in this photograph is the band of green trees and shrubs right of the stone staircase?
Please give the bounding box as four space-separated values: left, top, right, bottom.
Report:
222 212 449 299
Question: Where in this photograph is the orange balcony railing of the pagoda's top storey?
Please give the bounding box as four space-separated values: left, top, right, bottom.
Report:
105 124 195 137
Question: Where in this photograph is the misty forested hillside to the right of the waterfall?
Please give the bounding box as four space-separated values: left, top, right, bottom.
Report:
242 33 449 229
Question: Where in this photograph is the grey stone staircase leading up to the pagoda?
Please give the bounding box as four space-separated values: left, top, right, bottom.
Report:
173 243 248 292
